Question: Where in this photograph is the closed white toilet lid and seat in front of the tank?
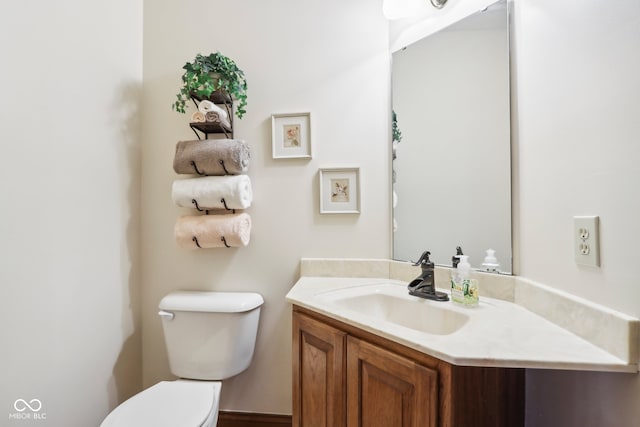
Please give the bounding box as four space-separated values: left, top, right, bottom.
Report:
100 380 222 427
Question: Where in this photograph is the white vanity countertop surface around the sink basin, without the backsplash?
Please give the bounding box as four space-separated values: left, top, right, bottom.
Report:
286 260 638 372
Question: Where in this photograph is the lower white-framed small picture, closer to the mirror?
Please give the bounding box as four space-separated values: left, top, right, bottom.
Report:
319 167 360 214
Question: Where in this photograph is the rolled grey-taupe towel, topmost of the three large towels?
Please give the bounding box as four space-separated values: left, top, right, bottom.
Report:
173 139 251 175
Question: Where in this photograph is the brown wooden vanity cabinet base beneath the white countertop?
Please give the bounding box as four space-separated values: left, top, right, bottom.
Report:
292 306 524 427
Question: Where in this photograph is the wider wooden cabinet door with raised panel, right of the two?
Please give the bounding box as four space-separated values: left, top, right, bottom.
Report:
347 337 438 427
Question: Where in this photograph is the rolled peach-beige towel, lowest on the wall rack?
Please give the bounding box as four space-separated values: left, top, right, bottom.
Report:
174 213 251 249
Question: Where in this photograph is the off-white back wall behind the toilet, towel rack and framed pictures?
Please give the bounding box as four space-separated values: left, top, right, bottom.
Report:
141 0 390 413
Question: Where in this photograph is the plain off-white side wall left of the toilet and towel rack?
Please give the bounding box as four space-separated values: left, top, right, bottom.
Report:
0 0 142 426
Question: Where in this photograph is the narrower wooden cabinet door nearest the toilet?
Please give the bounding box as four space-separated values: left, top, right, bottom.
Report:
292 312 346 427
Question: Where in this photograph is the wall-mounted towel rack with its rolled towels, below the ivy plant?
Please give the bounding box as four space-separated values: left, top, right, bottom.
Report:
171 96 252 250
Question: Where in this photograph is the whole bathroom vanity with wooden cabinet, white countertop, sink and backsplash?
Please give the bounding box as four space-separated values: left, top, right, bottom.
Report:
287 259 640 427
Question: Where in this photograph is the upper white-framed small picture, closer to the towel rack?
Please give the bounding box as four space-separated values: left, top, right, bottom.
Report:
271 113 311 159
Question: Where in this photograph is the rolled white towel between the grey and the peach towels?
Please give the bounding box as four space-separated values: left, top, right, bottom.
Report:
171 175 253 210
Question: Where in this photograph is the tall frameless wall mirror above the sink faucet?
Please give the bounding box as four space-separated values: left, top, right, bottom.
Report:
392 1 512 273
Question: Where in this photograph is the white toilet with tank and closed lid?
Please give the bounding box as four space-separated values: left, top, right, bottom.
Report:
100 291 264 427
